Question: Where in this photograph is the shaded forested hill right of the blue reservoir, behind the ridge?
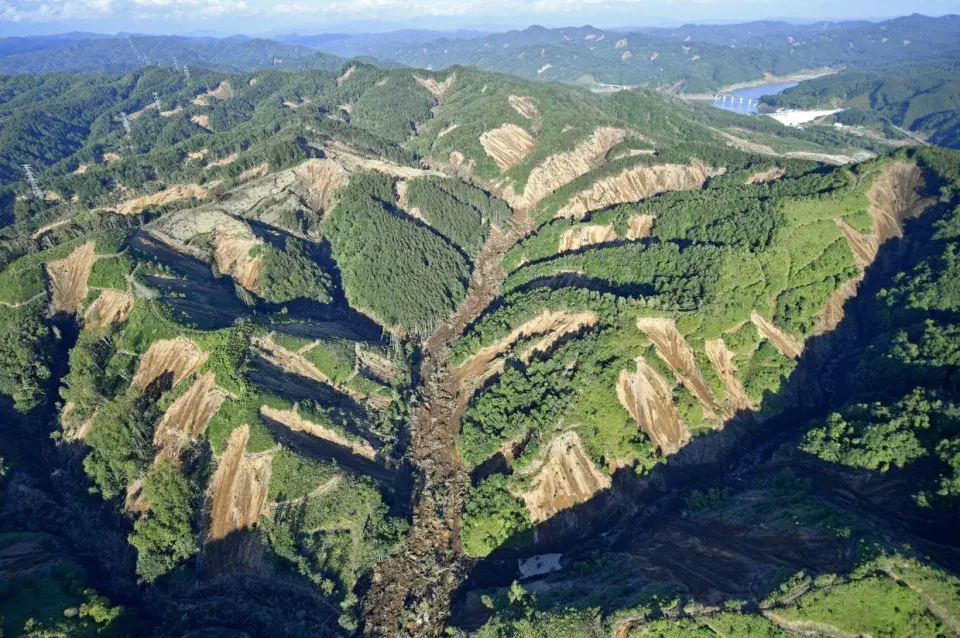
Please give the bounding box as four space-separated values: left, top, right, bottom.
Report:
764 61 960 148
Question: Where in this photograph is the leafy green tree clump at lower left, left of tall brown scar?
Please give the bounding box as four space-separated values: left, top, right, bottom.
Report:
130 461 199 582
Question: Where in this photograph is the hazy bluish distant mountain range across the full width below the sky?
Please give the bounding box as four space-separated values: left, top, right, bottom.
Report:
0 15 960 93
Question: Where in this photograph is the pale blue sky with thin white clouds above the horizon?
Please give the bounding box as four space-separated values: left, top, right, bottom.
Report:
0 0 960 36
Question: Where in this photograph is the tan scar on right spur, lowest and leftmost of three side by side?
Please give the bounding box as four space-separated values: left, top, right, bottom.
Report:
617 357 690 455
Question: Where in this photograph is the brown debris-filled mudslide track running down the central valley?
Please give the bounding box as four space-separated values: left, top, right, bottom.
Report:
364 210 535 638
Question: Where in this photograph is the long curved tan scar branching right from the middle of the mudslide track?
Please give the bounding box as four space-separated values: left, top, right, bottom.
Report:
454 310 597 387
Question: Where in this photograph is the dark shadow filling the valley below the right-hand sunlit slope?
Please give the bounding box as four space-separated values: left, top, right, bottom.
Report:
455 168 960 627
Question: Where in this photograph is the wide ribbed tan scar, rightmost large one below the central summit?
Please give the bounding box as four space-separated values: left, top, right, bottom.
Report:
556 161 722 219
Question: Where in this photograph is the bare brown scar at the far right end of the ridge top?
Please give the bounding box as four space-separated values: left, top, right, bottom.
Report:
836 162 934 268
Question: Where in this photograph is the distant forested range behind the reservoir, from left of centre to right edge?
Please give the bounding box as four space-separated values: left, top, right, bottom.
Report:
298 15 960 93
